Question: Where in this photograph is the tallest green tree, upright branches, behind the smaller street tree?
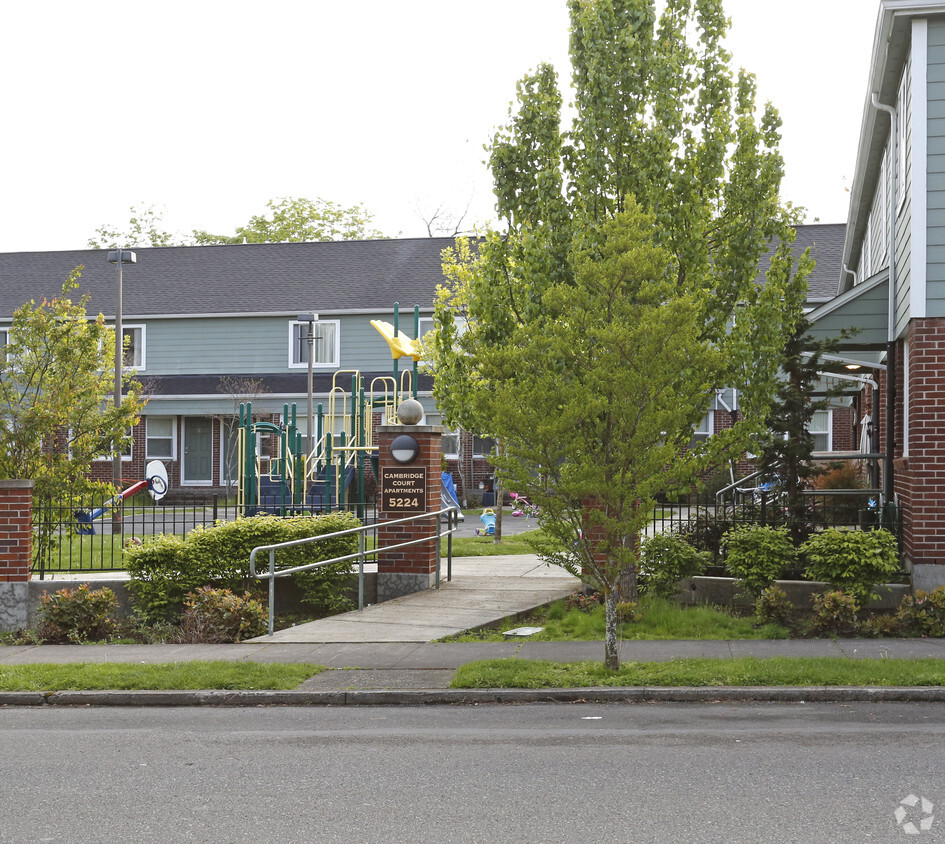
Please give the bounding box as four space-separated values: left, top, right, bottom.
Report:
430 0 803 672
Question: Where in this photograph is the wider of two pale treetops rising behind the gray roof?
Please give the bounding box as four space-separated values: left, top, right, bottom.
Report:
193 197 383 245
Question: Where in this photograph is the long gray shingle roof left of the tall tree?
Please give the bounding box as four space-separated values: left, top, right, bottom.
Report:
0 238 453 317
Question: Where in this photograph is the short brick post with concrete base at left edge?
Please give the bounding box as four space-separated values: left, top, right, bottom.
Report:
0 480 33 631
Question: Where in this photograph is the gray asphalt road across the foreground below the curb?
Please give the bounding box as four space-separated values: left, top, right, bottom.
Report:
0 704 945 844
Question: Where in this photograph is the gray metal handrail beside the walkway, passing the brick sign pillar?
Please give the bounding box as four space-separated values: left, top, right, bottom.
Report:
249 507 458 636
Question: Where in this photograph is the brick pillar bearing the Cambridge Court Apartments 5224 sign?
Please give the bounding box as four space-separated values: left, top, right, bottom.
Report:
377 425 445 601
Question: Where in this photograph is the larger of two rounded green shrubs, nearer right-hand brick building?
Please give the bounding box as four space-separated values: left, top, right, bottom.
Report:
800 528 899 604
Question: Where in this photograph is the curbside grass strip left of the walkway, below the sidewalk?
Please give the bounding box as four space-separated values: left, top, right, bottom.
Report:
0 660 325 692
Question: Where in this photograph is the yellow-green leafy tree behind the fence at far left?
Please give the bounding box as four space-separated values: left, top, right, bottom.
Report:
0 267 142 561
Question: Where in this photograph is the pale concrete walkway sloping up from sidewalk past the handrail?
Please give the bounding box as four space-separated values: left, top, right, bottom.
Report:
243 554 580 644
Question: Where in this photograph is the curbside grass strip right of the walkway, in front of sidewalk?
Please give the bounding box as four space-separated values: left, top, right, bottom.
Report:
452 657 945 689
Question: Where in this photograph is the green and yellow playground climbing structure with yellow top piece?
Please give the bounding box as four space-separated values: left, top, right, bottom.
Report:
237 303 432 519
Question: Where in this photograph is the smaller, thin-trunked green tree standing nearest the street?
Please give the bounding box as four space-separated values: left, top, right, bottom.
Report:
482 202 726 667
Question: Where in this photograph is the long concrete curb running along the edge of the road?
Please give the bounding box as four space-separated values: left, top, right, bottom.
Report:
0 686 945 707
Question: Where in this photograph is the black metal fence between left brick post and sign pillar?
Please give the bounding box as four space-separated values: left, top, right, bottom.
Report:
33 493 375 580
